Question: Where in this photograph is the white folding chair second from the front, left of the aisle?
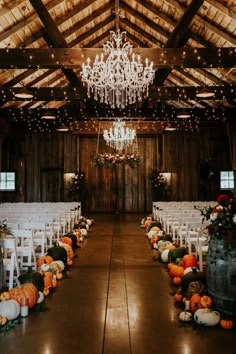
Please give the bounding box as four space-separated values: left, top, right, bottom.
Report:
12 229 37 270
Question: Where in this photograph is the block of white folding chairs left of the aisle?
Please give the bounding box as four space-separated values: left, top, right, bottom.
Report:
0 203 81 288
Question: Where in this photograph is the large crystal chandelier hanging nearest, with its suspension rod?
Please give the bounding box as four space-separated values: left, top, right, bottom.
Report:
81 0 155 108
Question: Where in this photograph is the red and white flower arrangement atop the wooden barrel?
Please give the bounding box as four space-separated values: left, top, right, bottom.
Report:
195 194 236 245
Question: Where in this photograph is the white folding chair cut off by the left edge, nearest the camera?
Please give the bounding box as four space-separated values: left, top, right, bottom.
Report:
0 237 20 289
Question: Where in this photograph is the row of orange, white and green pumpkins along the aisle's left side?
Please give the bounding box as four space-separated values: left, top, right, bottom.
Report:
0 217 94 332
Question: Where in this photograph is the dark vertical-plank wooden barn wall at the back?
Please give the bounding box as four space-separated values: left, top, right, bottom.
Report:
1 126 235 212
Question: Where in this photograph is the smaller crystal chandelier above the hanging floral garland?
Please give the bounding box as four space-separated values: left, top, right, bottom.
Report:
103 119 136 150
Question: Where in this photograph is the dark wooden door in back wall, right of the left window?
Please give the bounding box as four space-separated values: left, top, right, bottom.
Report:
40 168 64 202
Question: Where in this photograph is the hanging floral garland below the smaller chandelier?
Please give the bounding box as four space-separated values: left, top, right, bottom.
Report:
94 153 141 168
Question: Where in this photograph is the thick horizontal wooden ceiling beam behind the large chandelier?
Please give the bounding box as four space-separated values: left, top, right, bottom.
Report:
0 47 233 69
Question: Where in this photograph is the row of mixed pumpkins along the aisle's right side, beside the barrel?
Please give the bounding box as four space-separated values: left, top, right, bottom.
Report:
141 215 234 330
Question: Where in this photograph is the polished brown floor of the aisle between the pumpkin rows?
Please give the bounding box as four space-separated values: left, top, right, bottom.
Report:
0 214 236 354
